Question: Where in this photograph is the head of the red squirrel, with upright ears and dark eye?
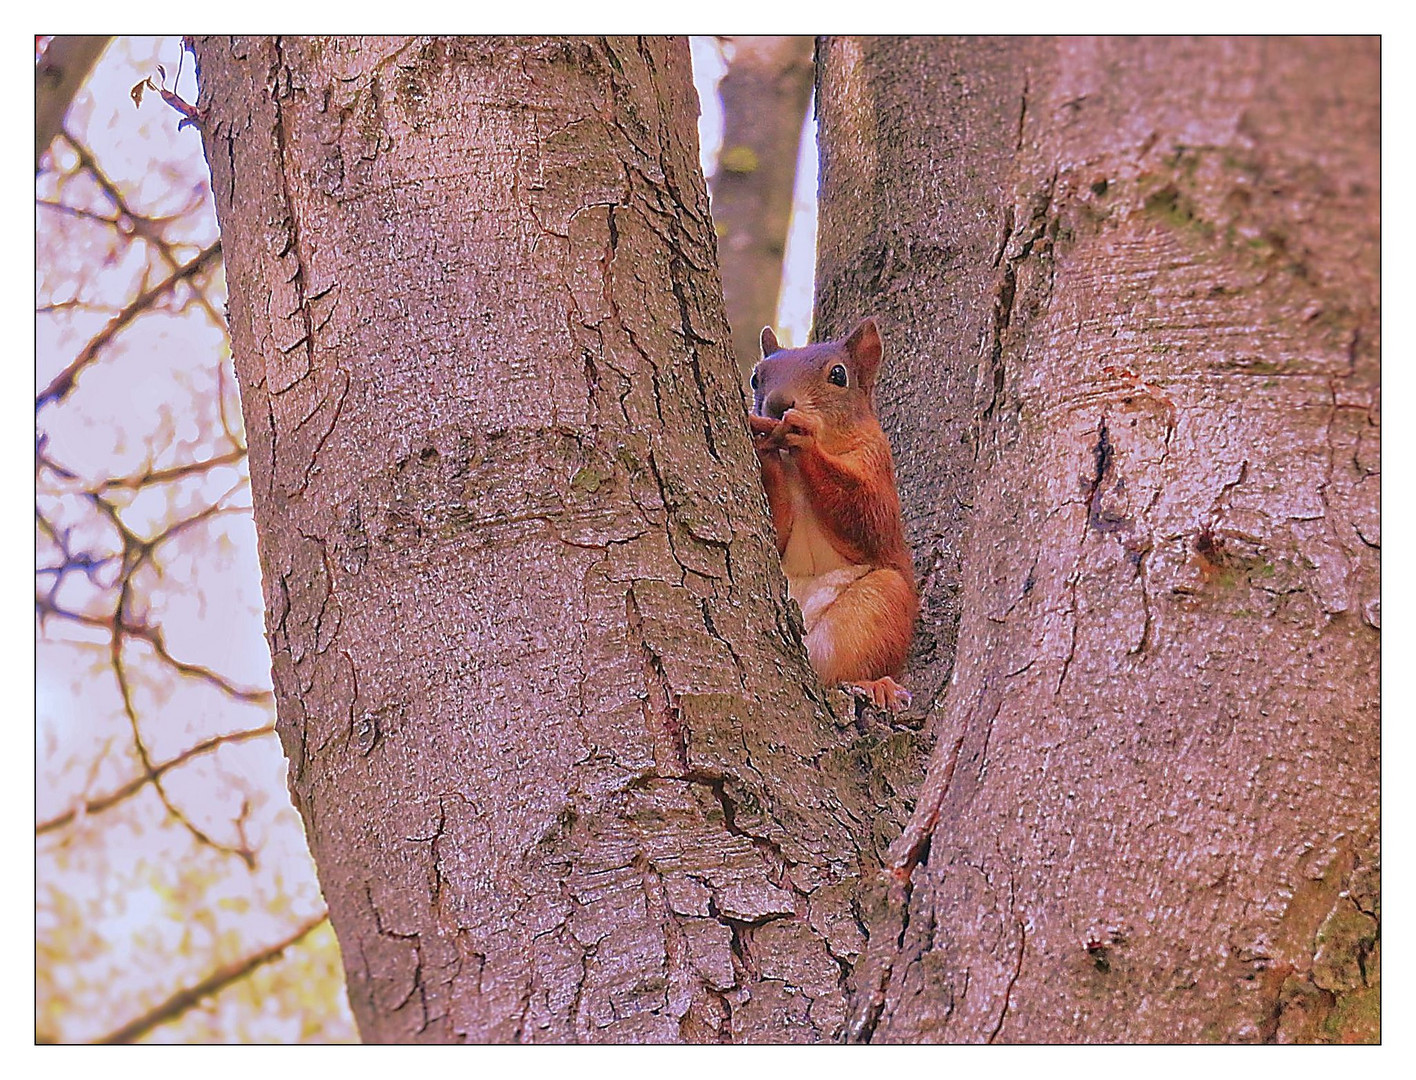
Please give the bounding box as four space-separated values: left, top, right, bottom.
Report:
752 318 882 425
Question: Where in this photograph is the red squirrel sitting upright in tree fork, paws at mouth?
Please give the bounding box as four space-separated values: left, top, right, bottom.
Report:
748 318 919 711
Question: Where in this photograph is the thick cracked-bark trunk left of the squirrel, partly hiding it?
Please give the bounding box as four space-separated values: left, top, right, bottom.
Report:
197 38 906 1042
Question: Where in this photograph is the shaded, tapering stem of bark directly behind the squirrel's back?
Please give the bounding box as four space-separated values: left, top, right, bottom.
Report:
814 37 1029 712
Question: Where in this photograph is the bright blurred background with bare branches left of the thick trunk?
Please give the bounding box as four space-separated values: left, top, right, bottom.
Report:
35 38 355 1042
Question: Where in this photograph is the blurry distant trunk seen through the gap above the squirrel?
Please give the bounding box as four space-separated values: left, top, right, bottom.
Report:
711 37 813 377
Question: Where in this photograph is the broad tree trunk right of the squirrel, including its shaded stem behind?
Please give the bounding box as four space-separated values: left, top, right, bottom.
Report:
818 38 1381 1042
